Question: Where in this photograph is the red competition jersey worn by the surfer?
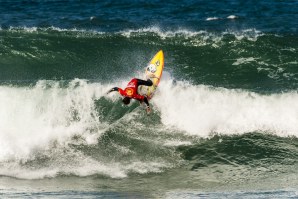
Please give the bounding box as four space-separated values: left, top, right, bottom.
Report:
118 78 145 101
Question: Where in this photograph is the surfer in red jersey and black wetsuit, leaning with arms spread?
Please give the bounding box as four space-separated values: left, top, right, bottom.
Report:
107 78 153 113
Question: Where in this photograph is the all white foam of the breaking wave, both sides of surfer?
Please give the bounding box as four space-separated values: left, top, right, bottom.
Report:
0 76 298 179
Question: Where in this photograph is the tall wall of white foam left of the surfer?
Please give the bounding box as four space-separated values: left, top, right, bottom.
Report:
0 80 105 161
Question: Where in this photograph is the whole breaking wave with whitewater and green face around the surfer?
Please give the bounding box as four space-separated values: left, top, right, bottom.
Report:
0 75 298 179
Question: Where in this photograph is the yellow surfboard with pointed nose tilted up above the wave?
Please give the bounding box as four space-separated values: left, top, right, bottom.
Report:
140 50 164 99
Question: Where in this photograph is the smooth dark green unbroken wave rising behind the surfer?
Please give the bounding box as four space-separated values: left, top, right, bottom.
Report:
0 27 298 92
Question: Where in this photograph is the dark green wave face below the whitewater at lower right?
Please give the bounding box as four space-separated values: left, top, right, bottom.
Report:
179 133 298 172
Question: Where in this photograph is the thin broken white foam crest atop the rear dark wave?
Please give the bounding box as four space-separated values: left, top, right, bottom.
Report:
2 25 263 47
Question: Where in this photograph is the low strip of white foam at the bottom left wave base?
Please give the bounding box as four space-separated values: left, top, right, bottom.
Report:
0 151 127 179
